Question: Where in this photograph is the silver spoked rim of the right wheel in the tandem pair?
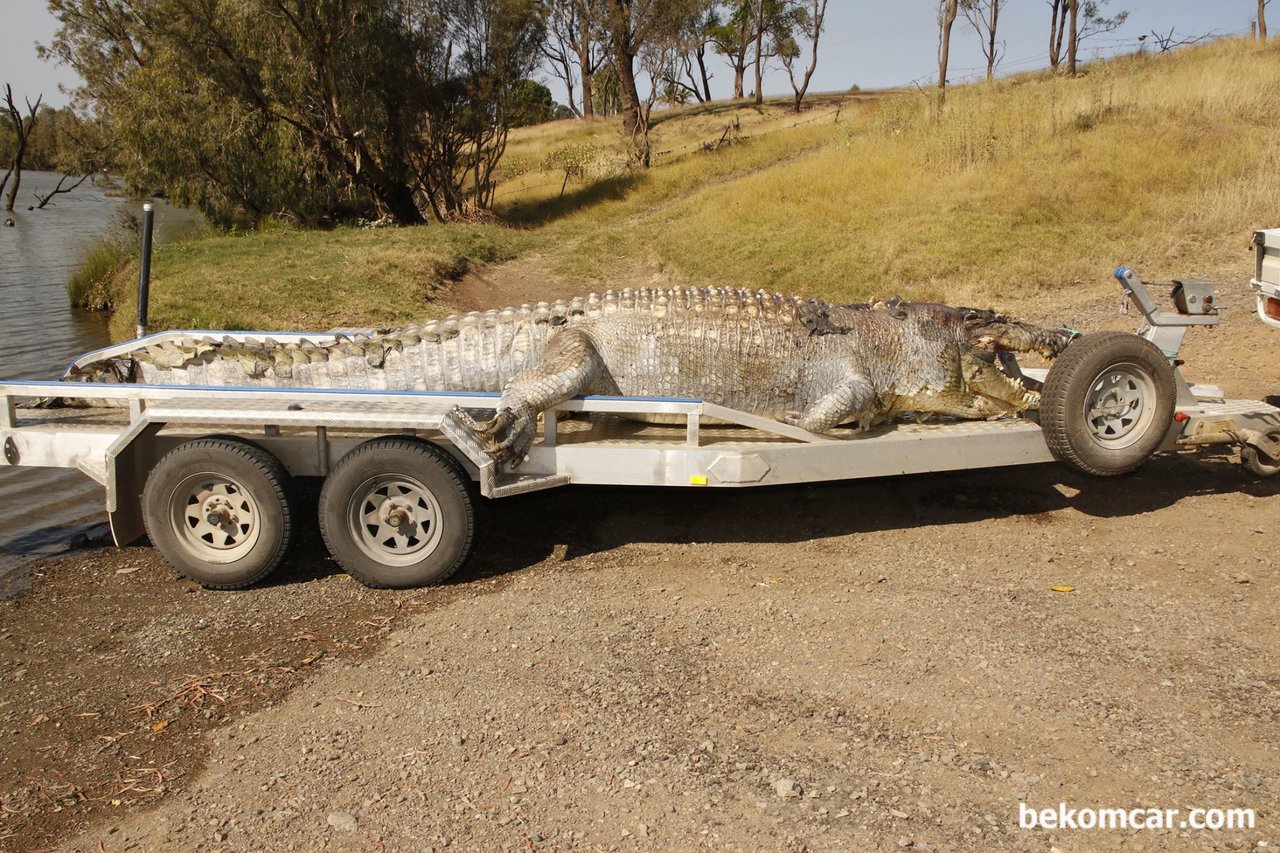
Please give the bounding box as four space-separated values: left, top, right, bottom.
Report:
347 474 443 566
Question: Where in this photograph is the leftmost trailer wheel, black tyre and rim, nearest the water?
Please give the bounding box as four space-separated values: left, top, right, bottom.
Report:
142 438 293 589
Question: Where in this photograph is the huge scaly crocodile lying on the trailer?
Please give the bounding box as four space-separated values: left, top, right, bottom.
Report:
64 288 1069 465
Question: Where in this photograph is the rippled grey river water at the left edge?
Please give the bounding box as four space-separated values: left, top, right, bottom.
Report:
0 172 198 596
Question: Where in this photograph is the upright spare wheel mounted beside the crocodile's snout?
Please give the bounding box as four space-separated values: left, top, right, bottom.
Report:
1041 332 1178 476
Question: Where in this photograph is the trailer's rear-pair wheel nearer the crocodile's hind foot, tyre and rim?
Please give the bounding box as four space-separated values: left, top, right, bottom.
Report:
320 438 475 589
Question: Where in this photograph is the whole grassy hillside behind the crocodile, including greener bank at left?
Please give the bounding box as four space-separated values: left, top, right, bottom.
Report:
87 40 1280 333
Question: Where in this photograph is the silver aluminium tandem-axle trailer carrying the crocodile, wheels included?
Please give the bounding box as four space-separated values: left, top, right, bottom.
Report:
0 269 1280 588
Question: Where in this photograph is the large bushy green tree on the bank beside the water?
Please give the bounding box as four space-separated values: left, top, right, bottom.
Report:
45 0 543 223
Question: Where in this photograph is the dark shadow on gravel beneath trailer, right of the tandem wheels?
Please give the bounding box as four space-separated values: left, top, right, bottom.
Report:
453 457 1280 583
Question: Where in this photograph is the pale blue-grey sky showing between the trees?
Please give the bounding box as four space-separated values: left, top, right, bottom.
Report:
0 0 1259 106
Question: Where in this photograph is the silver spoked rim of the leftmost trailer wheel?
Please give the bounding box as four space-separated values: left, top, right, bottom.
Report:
169 471 262 564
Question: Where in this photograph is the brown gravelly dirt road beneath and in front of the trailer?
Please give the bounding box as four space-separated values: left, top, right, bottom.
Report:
0 266 1280 850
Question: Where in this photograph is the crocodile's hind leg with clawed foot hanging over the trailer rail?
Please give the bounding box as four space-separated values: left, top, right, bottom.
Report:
453 329 612 466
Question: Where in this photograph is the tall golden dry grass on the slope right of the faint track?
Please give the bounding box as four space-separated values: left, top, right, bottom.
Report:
561 42 1280 308
